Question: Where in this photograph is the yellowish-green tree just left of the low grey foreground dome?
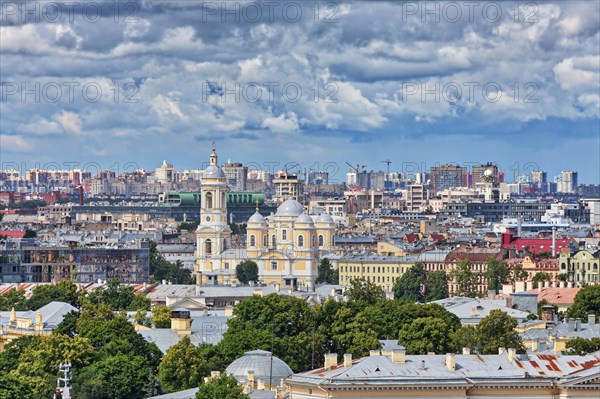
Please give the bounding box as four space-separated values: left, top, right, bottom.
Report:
158 337 206 392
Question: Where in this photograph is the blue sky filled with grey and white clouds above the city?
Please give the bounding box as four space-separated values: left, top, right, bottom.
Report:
0 0 600 183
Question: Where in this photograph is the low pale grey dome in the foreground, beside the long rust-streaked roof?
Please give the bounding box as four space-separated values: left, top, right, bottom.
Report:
225 350 294 386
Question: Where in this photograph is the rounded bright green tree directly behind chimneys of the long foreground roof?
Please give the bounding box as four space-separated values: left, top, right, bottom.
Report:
398 317 454 355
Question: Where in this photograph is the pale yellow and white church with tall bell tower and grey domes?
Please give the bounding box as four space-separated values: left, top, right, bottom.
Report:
196 142 335 289
